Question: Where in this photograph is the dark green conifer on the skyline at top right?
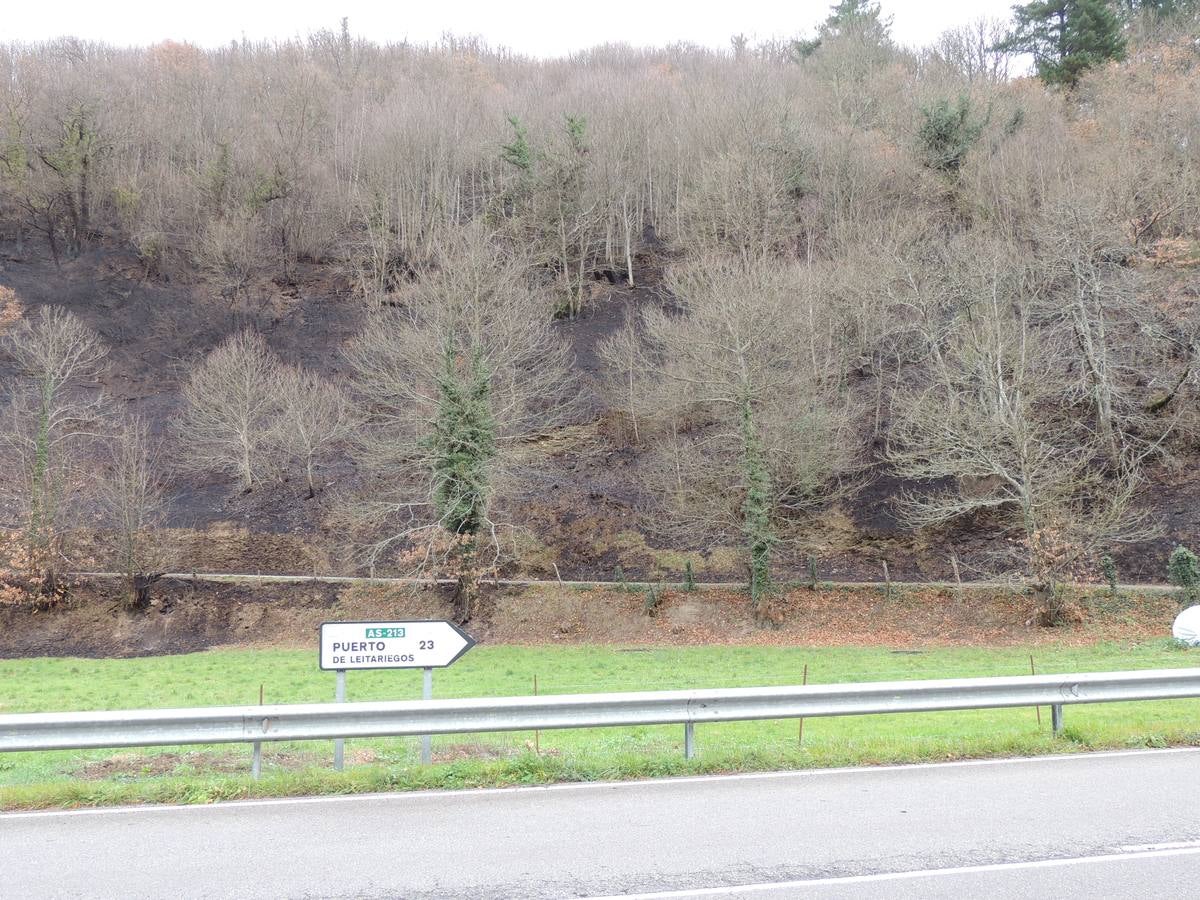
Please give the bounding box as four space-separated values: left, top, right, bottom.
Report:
997 0 1126 88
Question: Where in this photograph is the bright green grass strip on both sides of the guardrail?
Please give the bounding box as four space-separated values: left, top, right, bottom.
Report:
0 641 1200 809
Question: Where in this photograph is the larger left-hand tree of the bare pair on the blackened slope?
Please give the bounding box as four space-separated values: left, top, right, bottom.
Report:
175 331 280 491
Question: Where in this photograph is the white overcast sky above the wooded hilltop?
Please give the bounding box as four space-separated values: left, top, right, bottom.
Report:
0 0 1013 56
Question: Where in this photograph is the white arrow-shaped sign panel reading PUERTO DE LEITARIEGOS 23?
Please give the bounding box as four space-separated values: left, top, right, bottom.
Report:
320 622 475 671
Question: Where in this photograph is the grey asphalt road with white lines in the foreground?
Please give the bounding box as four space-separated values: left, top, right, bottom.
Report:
0 750 1200 900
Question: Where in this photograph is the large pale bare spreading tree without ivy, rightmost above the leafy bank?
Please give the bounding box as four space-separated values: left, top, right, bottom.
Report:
890 258 1153 622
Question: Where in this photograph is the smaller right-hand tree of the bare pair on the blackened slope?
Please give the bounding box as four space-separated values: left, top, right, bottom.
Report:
272 366 355 498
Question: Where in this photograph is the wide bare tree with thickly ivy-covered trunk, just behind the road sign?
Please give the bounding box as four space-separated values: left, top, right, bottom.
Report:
347 226 570 620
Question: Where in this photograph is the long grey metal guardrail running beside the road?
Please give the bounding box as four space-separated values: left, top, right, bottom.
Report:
0 667 1200 757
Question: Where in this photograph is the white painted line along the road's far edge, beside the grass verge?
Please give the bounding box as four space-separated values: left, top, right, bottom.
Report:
0 746 1200 822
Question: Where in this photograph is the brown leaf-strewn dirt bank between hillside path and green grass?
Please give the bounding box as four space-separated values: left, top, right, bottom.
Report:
0 578 1178 656
